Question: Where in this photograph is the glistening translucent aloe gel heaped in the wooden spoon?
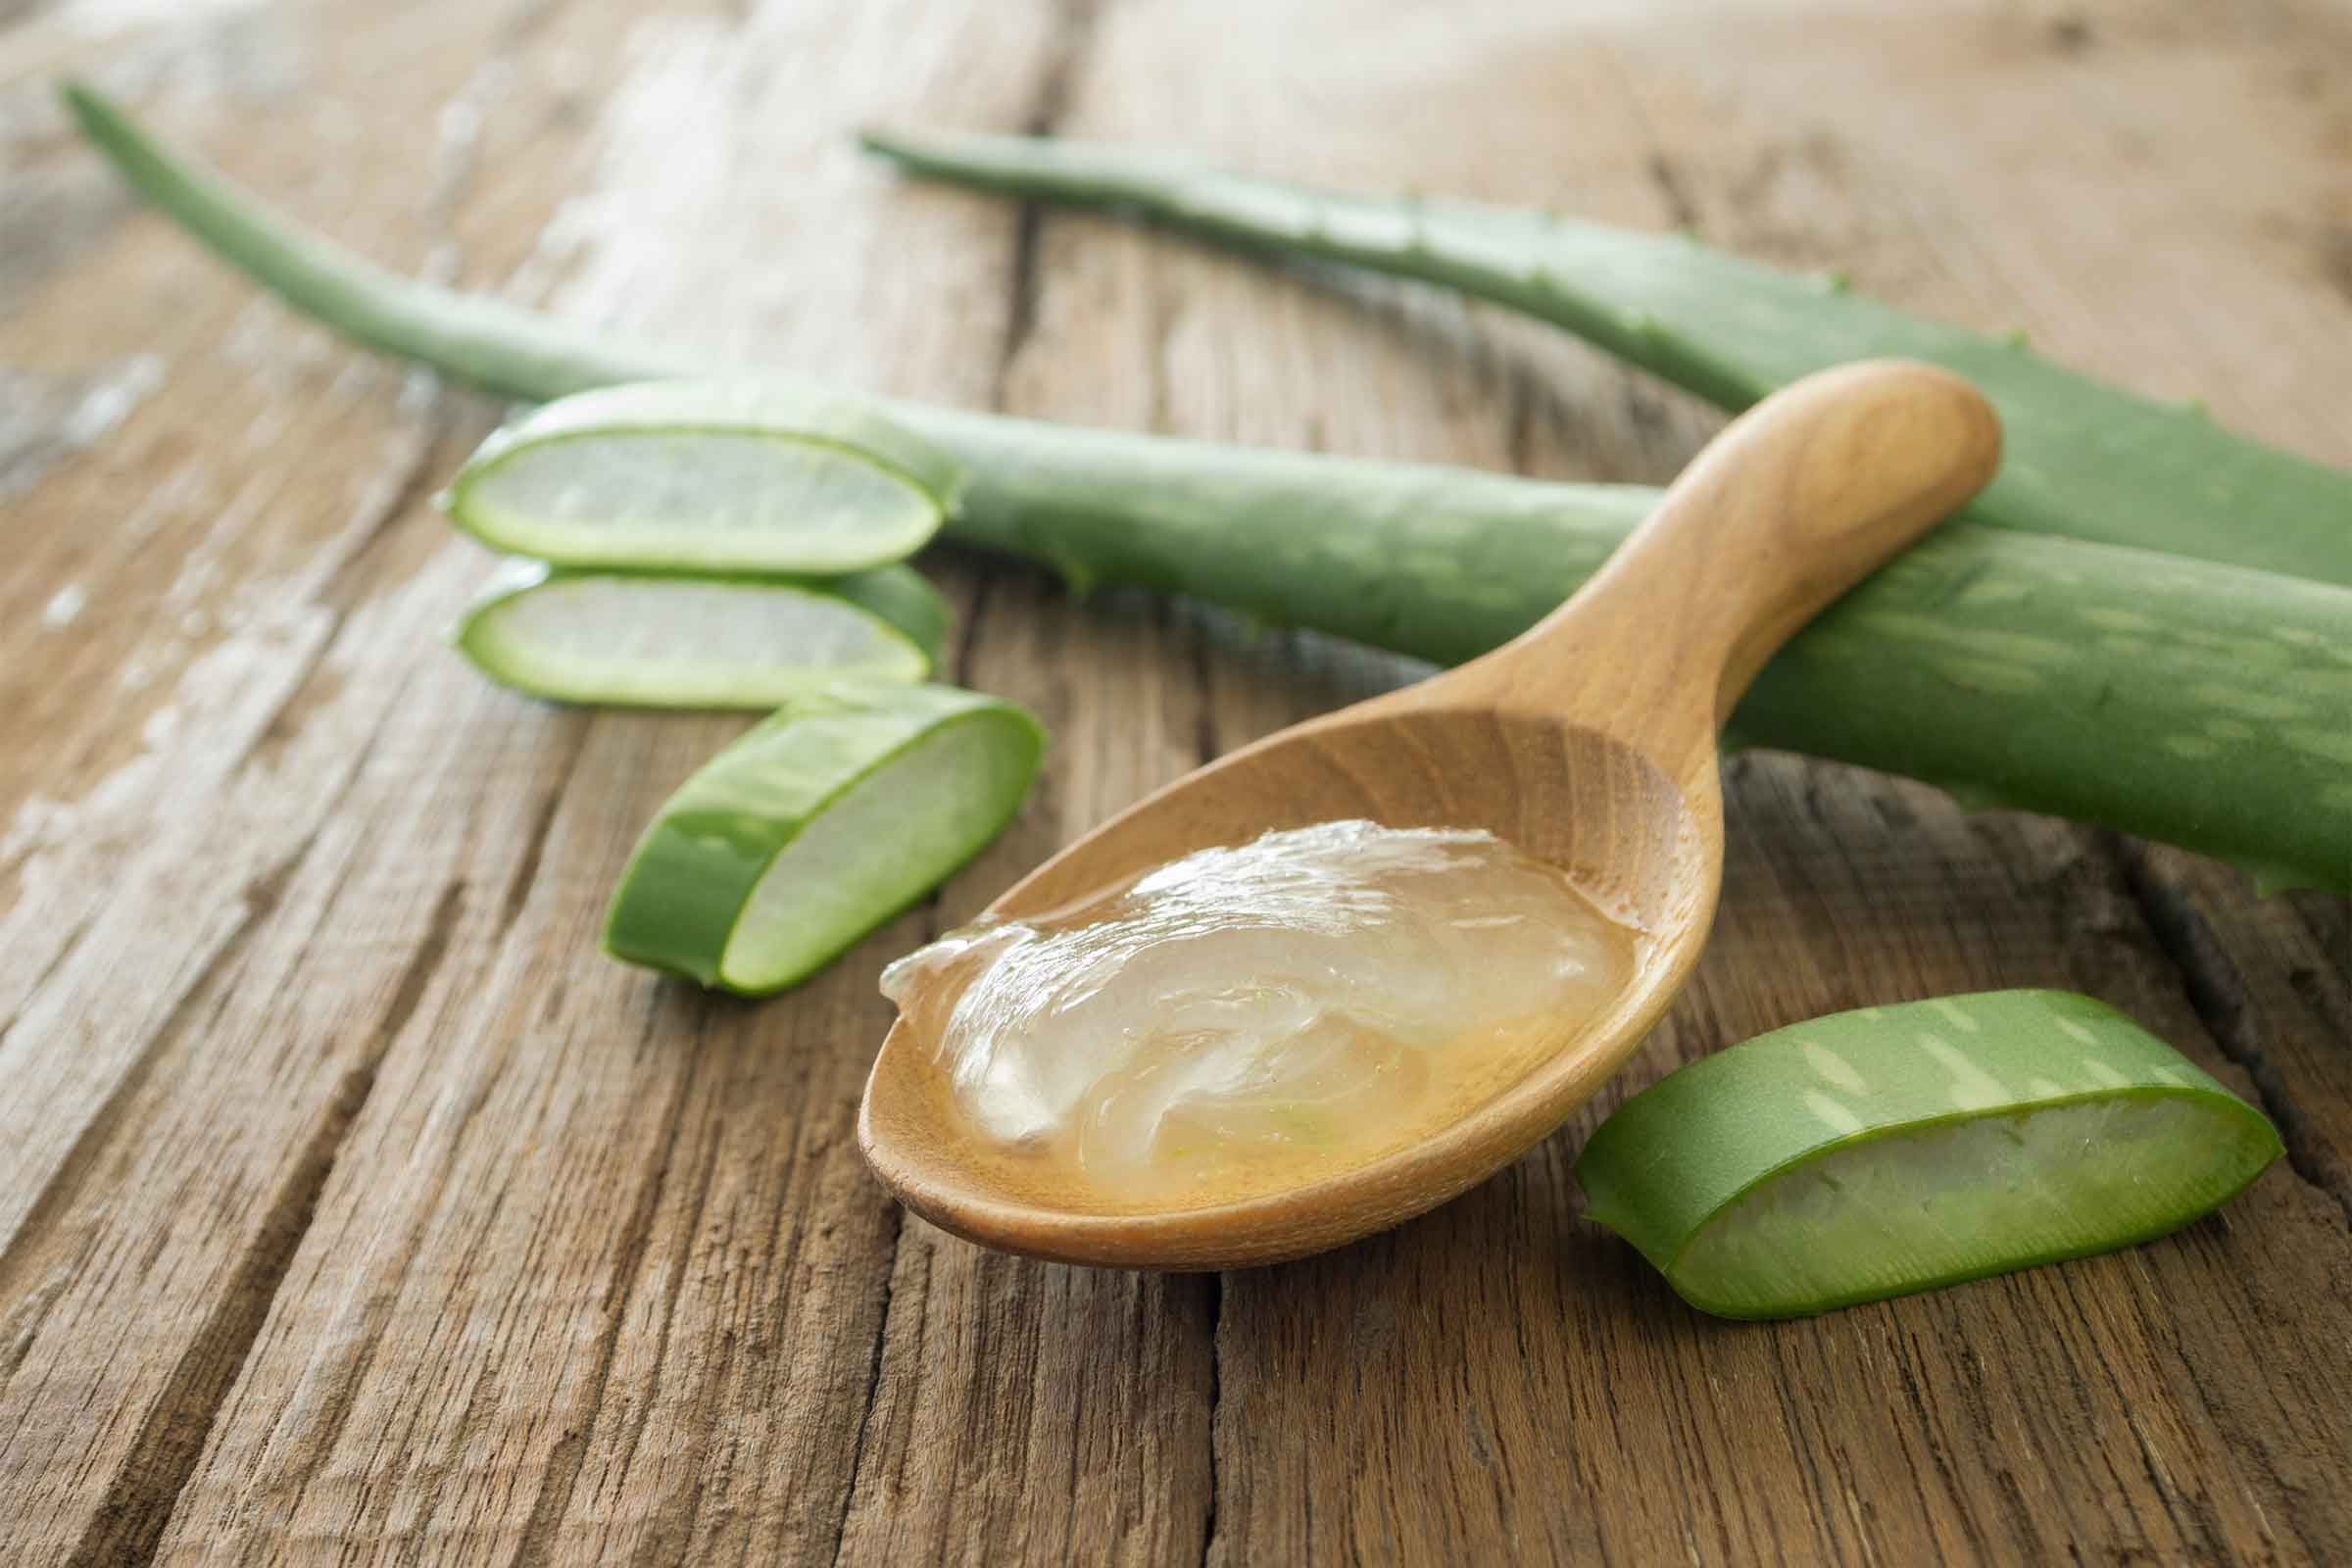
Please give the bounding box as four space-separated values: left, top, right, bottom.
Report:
882 820 1635 1201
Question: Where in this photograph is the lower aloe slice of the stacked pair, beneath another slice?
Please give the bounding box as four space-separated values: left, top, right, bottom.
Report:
457 562 948 708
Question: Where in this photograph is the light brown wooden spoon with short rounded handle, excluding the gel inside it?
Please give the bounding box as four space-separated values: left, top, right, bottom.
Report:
858 360 2001 1269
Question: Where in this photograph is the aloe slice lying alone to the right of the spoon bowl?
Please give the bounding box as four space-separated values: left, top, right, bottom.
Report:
1576 990 2279 1319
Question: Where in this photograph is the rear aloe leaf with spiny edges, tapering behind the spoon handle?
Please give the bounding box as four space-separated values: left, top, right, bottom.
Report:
865 134 2352 588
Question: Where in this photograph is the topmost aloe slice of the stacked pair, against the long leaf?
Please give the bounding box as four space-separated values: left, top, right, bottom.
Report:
442 381 959 573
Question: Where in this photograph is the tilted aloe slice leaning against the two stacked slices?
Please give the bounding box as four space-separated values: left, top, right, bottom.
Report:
605 684 1045 997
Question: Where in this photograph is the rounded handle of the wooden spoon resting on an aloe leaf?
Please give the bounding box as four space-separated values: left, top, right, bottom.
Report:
1460 360 2001 741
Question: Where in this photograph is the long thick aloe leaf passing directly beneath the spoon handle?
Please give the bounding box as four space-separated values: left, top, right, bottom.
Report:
59 94 2352 891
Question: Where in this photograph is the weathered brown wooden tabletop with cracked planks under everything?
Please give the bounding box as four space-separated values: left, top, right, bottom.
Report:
0 0 2352 1563
